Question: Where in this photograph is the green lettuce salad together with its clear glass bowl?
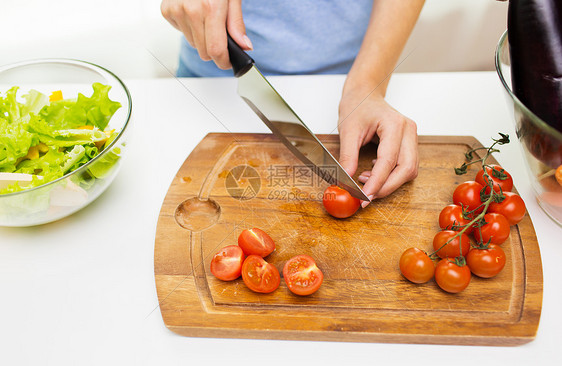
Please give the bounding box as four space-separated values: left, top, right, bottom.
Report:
0 60 131 226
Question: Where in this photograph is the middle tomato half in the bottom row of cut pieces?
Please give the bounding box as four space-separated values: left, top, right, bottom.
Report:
242 254 281 294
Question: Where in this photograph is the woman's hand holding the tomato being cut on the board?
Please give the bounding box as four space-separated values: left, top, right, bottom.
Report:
338 91 418 207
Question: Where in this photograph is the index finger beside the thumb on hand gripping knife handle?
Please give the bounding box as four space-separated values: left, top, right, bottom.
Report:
205 1 231 70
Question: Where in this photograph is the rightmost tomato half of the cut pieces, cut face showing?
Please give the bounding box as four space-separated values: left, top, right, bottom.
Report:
283 254 324 296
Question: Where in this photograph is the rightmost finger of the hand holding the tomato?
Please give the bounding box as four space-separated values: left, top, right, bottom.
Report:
377 122 419 198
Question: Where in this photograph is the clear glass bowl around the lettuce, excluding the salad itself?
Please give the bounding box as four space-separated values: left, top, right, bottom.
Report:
0 59 132 227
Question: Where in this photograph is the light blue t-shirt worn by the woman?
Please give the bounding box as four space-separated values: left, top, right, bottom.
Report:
177 0 373 77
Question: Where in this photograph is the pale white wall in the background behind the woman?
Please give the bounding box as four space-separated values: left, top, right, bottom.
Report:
0 0 507 78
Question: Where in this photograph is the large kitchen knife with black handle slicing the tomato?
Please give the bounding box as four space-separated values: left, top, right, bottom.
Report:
228 35 370 202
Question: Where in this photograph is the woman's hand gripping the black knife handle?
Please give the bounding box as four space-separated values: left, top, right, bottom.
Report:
160 0 253 69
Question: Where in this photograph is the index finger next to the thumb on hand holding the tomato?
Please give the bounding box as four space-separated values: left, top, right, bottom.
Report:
363 122 404 202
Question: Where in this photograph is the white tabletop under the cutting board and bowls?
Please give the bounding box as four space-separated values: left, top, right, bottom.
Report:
0 72 562 365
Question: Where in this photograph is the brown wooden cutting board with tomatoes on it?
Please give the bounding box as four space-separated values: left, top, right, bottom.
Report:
154 134 542 346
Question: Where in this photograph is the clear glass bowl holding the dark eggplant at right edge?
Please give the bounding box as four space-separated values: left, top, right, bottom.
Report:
495 31 562 225
